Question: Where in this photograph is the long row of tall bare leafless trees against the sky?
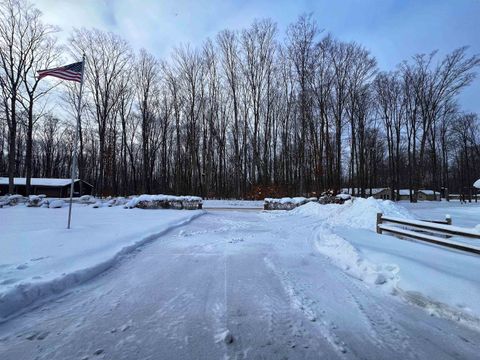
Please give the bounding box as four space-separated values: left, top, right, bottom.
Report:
0 0 480 201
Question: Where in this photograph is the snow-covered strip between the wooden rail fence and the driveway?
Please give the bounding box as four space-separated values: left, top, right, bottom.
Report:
334 227 480 329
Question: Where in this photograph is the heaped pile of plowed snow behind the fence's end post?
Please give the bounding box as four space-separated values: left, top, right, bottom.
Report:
292 197 413 230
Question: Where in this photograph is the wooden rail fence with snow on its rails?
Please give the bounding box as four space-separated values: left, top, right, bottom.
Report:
377 213 480 255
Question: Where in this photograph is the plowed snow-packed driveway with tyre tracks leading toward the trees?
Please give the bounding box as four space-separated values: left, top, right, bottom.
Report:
0 211 480 360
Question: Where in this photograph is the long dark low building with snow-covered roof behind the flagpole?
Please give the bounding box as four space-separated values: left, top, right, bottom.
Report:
0 177 93 198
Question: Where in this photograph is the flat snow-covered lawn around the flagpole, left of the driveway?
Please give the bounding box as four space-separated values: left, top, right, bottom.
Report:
0 204 203 322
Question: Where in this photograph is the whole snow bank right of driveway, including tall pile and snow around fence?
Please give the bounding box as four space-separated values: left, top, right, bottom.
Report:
289 198 480 328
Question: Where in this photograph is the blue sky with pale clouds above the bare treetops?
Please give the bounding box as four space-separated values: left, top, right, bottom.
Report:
33 0 480 113
